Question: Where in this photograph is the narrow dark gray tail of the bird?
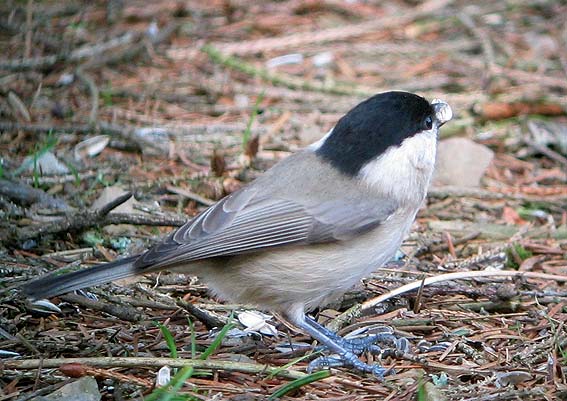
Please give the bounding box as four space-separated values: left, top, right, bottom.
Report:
22 256 141 299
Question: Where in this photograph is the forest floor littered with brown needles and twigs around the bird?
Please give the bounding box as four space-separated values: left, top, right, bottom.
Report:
0 0 567 401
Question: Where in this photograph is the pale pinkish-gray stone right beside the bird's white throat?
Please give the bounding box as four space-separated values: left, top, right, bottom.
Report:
433 138 494 187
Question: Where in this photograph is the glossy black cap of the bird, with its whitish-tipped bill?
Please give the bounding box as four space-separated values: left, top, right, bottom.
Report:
316 91 452 176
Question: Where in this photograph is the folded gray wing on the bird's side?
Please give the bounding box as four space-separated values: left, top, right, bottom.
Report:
134 187 396 268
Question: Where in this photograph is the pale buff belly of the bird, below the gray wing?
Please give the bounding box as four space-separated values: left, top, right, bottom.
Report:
197 206 415 312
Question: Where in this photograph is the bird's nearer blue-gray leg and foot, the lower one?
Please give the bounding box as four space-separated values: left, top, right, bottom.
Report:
290 316 389 378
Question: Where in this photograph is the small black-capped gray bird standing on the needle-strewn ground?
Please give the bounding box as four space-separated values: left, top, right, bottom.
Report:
23 91 453 376
